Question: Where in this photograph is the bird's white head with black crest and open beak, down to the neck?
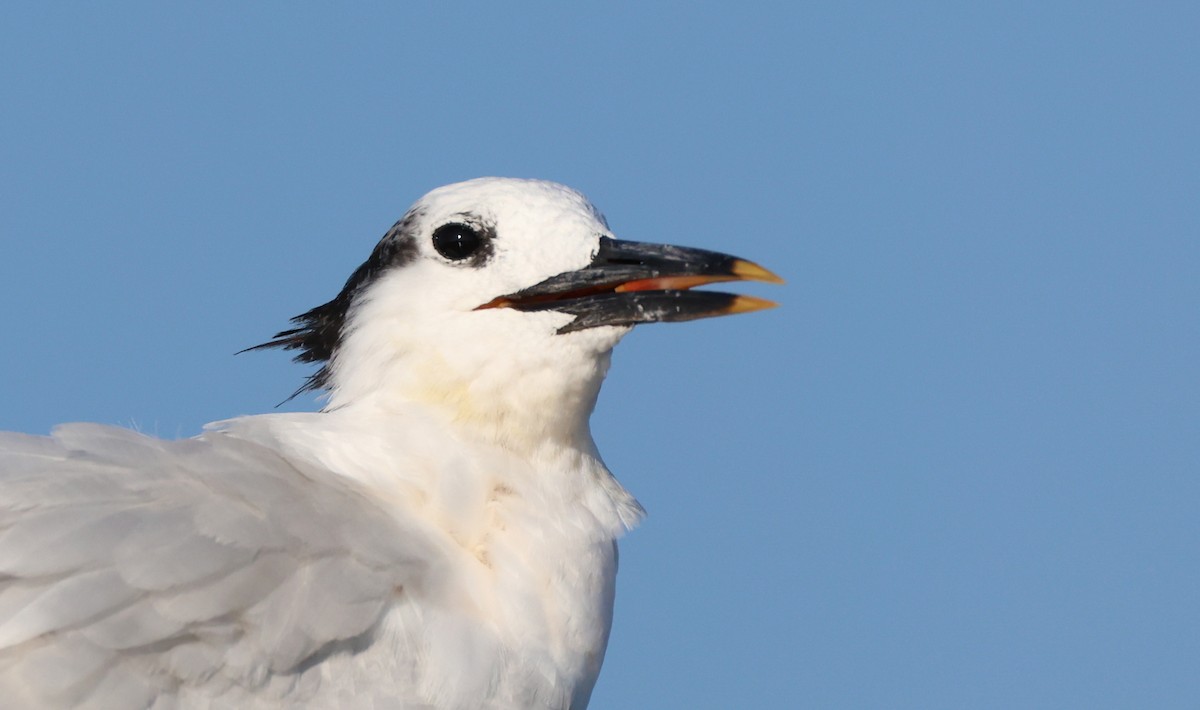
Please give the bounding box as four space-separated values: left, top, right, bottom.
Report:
252 178 780 439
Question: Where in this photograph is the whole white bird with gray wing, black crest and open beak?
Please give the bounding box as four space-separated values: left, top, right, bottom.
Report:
0 178 779 710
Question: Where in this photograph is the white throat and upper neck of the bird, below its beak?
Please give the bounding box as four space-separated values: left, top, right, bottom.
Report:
326 278 629 452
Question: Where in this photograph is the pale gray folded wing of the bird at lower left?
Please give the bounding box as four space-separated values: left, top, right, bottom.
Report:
0 425 436 708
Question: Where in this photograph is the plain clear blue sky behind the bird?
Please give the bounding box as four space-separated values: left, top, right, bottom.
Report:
0 2 1200 710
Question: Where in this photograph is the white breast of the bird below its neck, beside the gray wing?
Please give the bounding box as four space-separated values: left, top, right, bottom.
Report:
206 411 641 710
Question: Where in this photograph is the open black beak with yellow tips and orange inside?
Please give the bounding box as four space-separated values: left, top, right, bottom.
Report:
476 236 784 333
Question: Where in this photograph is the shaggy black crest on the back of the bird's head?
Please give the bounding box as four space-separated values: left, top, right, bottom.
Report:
242 210 424 399
